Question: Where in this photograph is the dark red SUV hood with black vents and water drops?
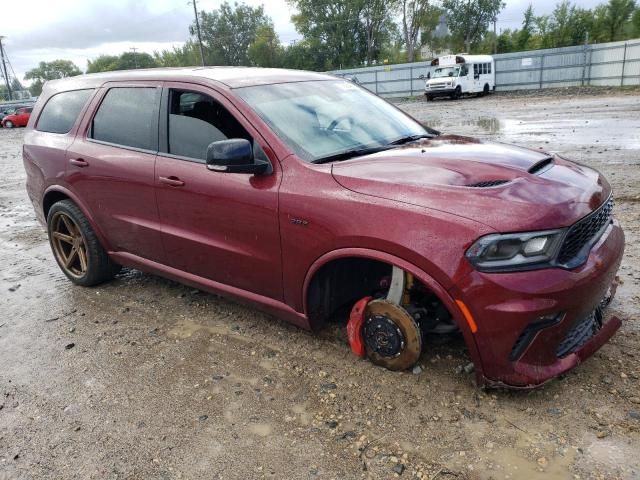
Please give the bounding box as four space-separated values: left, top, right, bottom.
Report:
332 135 611 232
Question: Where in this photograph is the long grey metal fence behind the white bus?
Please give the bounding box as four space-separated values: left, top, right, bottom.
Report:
331 39 640 97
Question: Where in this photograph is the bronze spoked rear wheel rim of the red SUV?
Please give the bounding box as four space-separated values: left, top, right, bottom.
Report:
51 212 89 278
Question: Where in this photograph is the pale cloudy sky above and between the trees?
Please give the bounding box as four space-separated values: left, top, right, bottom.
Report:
0 0 605 83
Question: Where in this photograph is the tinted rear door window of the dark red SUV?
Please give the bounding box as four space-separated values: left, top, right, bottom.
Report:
91 87 160 151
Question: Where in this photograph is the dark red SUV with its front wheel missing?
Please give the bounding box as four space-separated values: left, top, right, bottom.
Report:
24 67 624 387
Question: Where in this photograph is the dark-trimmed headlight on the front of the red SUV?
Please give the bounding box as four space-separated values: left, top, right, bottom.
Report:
465 230 564 272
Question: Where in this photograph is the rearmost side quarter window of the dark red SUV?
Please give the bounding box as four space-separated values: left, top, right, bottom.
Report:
37 89 93 133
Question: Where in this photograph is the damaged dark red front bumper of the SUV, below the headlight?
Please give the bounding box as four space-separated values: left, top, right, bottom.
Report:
451 221 624 387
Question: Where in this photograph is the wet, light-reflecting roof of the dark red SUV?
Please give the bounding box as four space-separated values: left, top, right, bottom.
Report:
42 67 336 94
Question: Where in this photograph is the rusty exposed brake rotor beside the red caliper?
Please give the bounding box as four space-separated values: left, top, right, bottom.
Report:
363 300 422 370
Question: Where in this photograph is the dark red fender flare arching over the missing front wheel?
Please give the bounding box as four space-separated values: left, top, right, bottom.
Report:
302 248 484 380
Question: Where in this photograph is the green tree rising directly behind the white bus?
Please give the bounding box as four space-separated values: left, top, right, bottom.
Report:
442 0 505 51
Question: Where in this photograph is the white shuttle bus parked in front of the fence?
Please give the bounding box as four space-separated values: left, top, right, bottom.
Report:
424 54 496 100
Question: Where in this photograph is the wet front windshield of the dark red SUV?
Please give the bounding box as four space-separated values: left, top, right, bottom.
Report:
235 80 427 162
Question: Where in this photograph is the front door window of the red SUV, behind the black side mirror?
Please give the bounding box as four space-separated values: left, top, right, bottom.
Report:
168 90 251 161
